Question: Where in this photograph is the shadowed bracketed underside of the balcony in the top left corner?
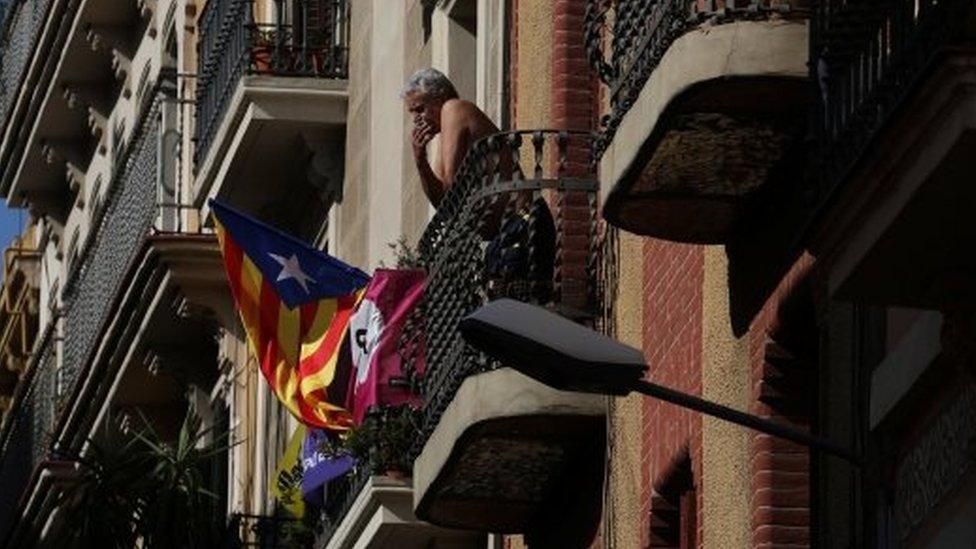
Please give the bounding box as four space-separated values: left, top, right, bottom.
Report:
0 0 142 208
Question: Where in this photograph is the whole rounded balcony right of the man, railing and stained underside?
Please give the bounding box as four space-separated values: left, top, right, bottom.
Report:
586 0 812 243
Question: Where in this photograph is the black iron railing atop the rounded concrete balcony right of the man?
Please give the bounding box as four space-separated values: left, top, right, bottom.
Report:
585 0 808 154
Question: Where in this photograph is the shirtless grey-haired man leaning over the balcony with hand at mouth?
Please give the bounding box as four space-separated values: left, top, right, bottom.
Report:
400 68 498 208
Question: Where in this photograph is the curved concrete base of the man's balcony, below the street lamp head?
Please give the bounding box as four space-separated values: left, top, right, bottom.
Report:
413 368 605 533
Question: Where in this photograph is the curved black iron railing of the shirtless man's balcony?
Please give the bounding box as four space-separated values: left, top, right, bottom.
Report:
400 130 598 448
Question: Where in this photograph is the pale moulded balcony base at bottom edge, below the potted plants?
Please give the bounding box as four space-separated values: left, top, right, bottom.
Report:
325 476 485 549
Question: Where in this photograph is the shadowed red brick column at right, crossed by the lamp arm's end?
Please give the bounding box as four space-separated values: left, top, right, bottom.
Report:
749 256 817 548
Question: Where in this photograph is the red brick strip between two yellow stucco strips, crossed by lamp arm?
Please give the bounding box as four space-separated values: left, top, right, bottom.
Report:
641 239 704 547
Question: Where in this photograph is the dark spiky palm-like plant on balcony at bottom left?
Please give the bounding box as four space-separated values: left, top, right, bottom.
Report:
60 411 227 549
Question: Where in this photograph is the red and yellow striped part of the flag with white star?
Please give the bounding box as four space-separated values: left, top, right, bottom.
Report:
215 220 363 431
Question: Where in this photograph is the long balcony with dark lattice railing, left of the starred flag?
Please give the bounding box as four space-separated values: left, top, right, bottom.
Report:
0 94 227 547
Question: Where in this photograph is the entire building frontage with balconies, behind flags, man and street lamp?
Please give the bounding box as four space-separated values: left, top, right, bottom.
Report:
0 0 976 548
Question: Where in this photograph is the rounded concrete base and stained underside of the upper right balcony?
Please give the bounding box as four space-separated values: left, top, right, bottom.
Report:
600 19 810 243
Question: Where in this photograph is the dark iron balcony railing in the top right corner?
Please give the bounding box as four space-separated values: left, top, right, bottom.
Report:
810 0 972 202
